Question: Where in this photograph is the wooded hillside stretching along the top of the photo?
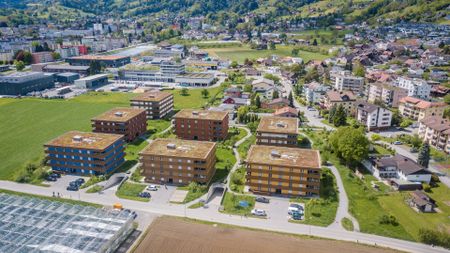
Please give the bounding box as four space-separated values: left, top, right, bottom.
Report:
0 0 450 23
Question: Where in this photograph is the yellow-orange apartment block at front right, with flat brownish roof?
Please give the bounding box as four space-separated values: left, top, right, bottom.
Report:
246 145 321 197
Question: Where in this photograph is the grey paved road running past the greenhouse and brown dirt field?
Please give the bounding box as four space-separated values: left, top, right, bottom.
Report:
0 181 450 253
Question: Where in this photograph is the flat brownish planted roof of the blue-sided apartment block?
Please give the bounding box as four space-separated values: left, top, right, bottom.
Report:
45 131 123 150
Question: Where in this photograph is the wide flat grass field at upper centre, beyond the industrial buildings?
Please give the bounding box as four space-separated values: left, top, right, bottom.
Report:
204 45 329 63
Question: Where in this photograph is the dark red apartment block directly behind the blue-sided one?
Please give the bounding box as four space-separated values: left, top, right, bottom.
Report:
91 108 147 142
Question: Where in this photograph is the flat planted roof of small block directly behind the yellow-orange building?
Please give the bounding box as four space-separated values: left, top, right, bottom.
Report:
256 116 298 134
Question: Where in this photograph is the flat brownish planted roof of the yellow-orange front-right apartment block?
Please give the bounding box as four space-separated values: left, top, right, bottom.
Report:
247 145 321 169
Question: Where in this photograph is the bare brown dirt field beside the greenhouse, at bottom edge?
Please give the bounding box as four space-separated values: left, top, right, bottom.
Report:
134 217 398 253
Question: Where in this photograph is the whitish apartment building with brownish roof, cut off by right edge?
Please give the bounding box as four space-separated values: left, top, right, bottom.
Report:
419 116 450 154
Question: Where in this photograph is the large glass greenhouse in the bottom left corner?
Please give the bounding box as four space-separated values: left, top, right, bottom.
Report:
0 194 133 253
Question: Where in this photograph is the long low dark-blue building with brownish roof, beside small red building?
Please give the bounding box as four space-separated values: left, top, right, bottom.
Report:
66 55 131 68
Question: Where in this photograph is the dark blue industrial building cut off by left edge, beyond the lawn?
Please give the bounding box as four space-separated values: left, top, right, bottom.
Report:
0 72 55 96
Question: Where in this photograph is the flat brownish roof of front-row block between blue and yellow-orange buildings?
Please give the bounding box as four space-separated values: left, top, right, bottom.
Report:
140 139 216 159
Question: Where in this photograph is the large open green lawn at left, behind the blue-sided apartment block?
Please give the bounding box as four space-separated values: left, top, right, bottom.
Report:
0 93 134 180
